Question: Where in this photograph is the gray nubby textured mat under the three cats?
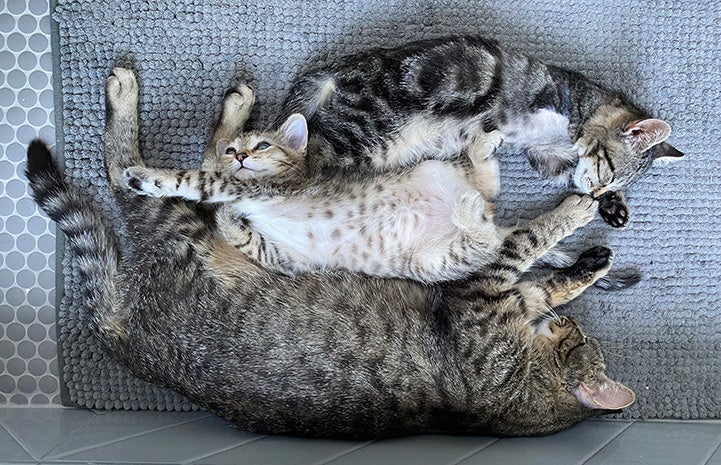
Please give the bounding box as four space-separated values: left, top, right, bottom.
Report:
54 0 721 418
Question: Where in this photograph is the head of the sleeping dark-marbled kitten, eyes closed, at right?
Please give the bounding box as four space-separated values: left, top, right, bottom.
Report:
573 105 683 197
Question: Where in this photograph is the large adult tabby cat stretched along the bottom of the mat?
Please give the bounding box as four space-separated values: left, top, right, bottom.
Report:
27 69 634 438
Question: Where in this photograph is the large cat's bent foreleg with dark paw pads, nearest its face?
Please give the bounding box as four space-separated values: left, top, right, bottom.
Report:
519 246 613 307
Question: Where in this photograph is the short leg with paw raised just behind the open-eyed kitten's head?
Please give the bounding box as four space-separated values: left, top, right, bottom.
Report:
202 84 255 170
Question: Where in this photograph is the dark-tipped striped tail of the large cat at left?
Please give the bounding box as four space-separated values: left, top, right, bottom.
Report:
25 139 125 342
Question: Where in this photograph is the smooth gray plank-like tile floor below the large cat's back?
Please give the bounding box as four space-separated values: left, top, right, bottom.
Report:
0 407 721 465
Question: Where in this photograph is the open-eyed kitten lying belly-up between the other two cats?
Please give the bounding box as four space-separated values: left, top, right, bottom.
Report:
125 95 520 283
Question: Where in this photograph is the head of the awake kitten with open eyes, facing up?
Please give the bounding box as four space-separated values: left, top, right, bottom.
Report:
216 114 308 179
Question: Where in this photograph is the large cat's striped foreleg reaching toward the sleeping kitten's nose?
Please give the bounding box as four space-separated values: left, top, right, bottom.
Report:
479 194 598 291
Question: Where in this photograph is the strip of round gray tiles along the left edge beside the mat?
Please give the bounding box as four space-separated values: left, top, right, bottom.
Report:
0 0 60 405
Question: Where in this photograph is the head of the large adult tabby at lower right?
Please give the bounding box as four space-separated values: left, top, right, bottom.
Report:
538 317 636 417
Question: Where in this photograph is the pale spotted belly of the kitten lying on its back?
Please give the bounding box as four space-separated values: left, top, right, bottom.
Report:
236 161 492 276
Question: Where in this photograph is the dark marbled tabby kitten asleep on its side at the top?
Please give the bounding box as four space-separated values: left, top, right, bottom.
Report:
283 37 683 227
